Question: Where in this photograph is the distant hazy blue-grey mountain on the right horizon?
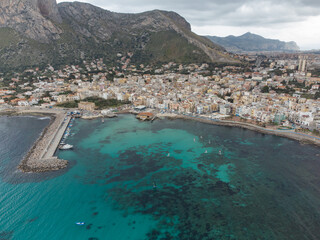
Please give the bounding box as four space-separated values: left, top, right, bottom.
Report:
206 32 300 52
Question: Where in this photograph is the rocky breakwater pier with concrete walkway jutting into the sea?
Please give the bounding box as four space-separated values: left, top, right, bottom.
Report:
18 110 70 172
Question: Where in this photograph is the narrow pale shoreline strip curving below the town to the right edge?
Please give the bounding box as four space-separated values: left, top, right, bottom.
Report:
157 114 320 147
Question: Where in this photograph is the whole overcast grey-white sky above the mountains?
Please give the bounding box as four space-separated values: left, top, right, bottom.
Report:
57 0 320 50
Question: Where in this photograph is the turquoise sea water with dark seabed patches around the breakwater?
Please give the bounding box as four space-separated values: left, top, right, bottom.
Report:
0 115 320 240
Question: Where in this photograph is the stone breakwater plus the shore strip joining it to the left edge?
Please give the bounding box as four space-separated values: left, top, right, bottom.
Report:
0 109 68 173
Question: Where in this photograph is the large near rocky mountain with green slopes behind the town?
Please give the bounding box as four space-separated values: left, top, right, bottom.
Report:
0 0 234 69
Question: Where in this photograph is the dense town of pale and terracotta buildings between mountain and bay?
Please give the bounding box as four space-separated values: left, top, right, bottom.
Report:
0 56 320 130
